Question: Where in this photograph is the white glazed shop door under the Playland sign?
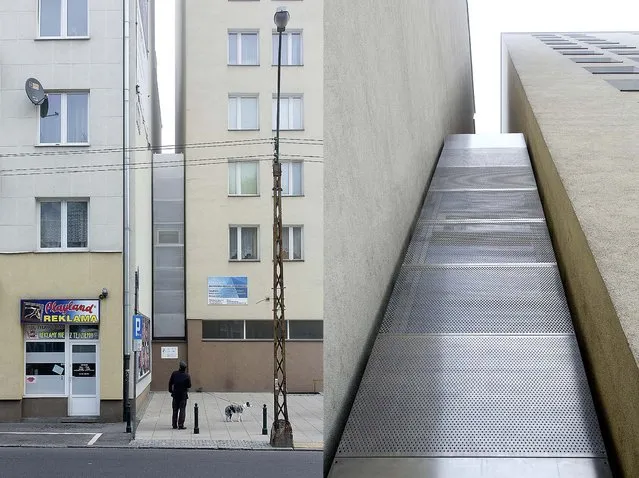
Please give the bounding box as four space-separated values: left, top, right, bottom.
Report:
69 342 100 416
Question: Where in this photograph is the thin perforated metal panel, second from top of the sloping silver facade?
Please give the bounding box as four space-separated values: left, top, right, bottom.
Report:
438 148 530 168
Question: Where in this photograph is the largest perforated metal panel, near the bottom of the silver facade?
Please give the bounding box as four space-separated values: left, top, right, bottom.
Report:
337 335 605 457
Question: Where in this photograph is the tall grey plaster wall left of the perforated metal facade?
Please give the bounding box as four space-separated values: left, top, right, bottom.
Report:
324 0 473 469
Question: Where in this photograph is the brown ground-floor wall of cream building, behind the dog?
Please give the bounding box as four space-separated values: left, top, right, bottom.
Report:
188 320 323 393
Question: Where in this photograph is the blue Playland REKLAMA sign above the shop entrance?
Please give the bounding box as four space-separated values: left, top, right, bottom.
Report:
20 299 100 324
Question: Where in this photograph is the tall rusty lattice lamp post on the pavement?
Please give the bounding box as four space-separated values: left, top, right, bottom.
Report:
271 7 293 448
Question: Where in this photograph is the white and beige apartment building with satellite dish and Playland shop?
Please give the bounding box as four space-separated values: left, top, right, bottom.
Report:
0 0 159 421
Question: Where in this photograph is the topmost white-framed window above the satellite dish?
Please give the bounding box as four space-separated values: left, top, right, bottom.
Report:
39 0 89 38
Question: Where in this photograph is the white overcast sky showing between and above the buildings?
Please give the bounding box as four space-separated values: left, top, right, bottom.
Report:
155 0 639 145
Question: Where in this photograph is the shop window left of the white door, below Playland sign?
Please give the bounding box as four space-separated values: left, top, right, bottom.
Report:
24 341 66 395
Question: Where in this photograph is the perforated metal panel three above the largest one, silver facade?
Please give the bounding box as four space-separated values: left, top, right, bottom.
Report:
419 191 544 221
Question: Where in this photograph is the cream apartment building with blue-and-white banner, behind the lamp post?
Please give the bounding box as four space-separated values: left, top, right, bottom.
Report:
159 0 324 392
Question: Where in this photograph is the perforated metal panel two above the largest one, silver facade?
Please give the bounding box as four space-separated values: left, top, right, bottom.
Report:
404 223 555 264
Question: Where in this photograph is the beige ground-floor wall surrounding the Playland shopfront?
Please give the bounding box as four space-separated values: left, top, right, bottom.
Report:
0 253 122 400
